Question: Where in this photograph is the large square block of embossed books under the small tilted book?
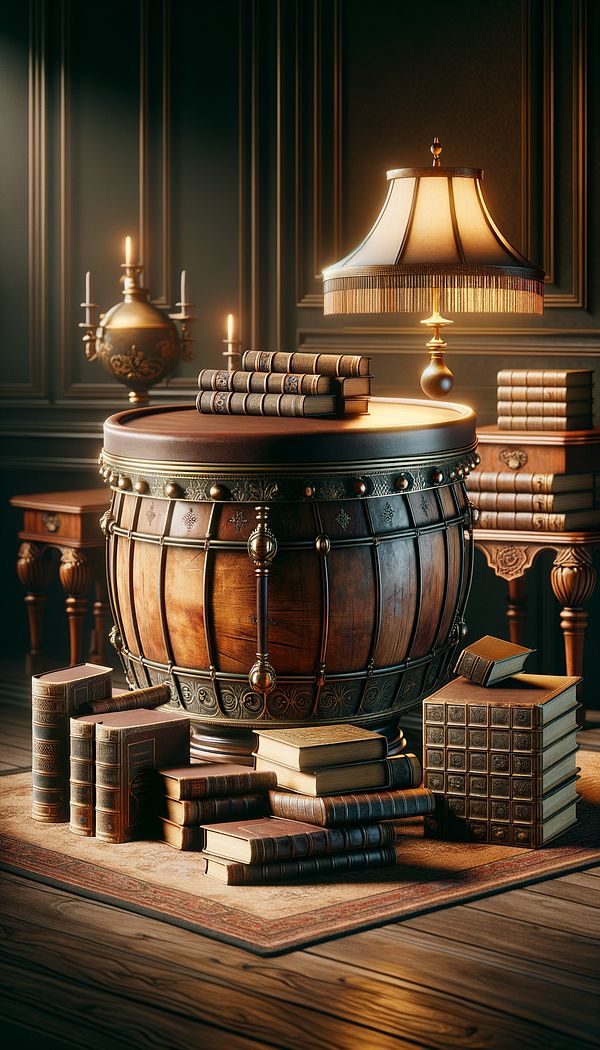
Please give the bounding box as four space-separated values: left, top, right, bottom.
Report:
423 646 580 847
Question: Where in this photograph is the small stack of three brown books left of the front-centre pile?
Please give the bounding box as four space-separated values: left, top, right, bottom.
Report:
152 762 276 849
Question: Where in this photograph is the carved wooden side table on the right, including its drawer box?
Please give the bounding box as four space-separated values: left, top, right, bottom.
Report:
473 426 600 692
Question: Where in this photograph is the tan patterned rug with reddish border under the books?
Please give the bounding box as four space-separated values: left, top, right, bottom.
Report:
0 751 600 956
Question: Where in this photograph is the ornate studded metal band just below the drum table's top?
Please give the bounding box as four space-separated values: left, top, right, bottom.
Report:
99 445 478 505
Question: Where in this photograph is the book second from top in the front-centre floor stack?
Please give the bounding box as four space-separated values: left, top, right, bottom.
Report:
255 754 421 795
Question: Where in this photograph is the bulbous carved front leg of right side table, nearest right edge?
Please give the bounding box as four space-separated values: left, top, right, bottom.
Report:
550 547 596 674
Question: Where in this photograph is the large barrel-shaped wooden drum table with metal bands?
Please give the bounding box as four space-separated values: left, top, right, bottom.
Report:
101 399 476 761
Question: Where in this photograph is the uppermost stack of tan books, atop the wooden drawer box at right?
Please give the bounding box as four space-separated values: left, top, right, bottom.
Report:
498 369 594 431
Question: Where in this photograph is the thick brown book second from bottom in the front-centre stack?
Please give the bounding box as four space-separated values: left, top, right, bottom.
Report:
204 817 411 864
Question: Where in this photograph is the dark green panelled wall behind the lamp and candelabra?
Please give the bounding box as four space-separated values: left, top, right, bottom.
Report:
0 0 600 697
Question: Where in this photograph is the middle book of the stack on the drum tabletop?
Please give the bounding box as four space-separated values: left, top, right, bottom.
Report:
198 369 371 397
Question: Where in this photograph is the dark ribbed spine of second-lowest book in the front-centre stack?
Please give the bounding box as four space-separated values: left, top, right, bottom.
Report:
250 821 397 864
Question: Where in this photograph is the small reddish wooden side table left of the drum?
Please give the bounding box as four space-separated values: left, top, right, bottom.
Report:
9 488 109 665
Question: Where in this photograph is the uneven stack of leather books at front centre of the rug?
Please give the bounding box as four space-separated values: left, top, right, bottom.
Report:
204 726 433 885
